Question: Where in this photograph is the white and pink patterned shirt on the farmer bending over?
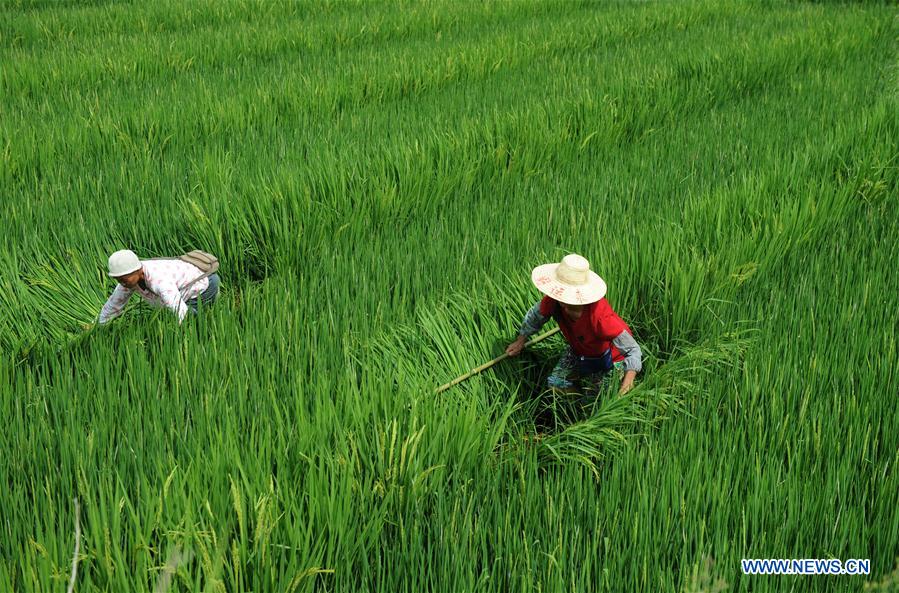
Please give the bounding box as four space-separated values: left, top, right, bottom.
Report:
97 259 209 323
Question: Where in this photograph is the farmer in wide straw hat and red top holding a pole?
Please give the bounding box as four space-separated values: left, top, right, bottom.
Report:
506 254 643 394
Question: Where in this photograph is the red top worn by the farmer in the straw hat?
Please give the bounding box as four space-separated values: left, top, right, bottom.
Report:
540 296 633 362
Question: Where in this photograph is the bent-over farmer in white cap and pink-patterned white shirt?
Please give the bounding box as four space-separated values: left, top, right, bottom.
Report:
97 249 219 324
